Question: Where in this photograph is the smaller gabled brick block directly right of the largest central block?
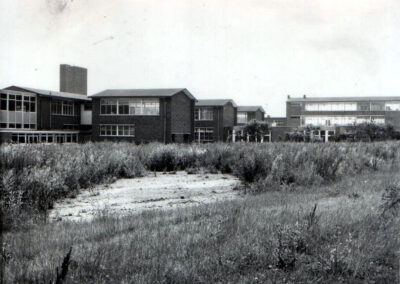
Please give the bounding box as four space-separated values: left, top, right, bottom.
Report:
194 99 237 143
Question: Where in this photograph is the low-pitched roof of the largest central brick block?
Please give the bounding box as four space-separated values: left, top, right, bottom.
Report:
90 88 196 100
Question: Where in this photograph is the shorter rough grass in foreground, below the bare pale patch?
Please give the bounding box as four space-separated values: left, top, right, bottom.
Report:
5 170 400 283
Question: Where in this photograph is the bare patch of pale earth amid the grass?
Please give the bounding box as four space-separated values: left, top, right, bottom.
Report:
49 172 240 221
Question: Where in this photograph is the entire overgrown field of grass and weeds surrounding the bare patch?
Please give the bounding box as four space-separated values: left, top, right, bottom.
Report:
1 142 400 283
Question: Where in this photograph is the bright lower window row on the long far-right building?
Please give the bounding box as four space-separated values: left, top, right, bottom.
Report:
302 116 385 126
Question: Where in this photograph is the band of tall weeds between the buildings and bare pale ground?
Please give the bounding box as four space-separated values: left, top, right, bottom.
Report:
0 142 400 229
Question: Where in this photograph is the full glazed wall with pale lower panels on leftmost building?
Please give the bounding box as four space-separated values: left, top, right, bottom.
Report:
0 91 36 129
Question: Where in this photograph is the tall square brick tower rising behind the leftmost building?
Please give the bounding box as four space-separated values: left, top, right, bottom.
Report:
60 64 87 95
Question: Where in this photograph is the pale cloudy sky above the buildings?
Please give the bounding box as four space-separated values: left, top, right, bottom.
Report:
0 0 400 116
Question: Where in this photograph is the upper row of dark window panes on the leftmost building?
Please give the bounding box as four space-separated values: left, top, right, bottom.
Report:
0 93 36 112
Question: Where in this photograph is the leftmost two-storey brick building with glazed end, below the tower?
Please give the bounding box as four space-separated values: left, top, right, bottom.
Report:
0 66 91 143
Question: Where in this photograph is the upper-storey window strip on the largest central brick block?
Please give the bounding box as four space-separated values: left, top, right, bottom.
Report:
100 98 160 115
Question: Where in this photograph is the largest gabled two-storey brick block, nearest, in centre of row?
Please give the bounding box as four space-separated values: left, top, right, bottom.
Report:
91 89 196 143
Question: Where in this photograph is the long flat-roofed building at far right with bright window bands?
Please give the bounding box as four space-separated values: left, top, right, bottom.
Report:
286 96 400 140
